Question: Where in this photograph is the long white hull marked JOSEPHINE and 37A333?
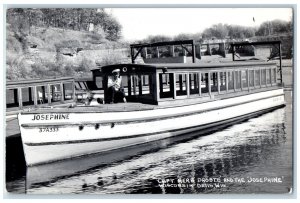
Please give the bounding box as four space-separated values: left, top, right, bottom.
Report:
19 89 285 166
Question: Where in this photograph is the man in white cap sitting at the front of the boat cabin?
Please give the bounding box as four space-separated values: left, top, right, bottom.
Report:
107 69 126 103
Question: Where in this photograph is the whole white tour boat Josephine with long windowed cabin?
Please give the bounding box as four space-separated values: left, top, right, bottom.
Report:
18 40 285 166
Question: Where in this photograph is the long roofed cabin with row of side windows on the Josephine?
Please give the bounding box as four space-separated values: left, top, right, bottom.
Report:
92 61 281 105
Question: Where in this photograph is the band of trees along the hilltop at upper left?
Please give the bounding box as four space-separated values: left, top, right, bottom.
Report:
6 8 122 41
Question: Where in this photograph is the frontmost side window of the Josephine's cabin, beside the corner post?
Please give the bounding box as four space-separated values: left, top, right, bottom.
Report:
159 73 173 98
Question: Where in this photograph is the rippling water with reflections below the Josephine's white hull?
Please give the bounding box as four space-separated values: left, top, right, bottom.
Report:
21 105 292 194
